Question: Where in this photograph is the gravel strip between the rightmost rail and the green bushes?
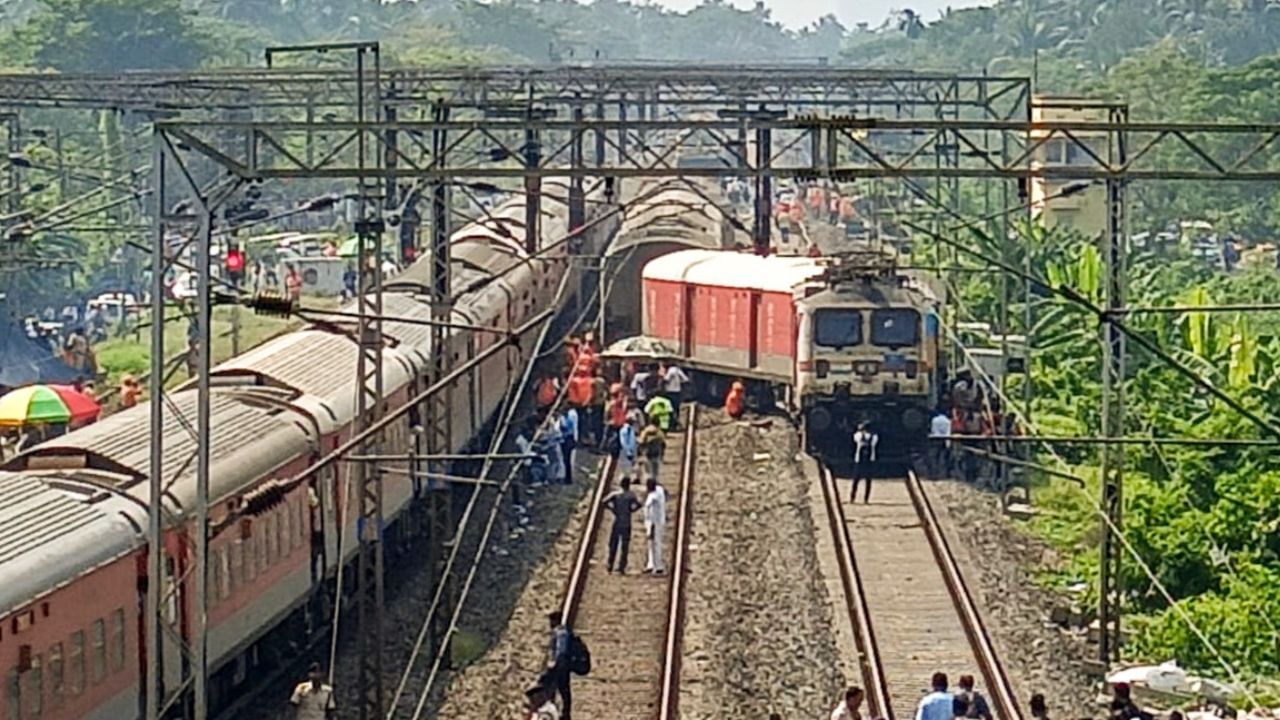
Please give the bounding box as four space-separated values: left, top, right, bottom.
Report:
924 480 1098 717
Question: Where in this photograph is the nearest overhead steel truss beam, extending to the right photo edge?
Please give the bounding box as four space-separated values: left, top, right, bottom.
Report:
156 115 1280 182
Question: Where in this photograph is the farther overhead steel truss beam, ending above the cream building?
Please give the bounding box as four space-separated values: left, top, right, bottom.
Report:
0 64 1030 118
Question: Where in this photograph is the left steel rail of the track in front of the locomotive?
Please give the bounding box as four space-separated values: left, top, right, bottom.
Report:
818 462 893 720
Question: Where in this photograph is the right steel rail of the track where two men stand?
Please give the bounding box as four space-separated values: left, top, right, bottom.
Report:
658 404 698 720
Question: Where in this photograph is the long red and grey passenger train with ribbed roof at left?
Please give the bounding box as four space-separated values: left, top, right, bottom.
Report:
0 183 617 720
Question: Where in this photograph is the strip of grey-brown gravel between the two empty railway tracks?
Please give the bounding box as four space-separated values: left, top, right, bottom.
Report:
680 410 844 720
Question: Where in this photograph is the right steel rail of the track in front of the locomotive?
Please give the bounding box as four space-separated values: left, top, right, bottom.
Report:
906 470 1023 720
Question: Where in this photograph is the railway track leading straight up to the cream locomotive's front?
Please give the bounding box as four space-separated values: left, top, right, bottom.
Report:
820 465 1023 720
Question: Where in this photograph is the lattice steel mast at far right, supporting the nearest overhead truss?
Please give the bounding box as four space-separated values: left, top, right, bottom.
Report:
1098 106 1129 667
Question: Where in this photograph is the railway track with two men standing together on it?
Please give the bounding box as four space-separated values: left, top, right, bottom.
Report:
563 405 698 720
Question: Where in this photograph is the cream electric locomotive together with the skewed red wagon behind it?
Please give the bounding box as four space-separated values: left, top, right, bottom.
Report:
643 250 940 459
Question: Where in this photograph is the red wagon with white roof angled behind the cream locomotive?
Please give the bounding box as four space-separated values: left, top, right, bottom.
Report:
643 250 822 386
